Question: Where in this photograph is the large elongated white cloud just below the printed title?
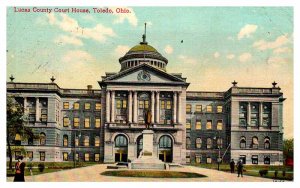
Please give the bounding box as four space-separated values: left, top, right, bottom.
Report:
47 13 116 42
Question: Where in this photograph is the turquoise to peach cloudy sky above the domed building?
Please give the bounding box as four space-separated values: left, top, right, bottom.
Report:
6 7 294 138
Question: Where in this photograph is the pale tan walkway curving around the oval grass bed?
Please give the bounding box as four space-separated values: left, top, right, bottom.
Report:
7 164 273 182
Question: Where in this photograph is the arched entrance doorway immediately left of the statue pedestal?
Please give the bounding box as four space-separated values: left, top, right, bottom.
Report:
115 135 128 162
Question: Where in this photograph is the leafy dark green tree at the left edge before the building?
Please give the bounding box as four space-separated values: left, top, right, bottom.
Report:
6 97 35 169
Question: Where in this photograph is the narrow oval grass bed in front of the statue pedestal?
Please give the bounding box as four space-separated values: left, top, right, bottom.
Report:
101 170 206 178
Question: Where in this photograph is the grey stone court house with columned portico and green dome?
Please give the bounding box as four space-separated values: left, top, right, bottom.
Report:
7 35 285 165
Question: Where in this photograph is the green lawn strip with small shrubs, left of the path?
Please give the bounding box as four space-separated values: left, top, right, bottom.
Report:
6 162 99 177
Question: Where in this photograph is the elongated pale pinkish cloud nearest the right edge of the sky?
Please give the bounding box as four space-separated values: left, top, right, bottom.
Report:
253 34 289 50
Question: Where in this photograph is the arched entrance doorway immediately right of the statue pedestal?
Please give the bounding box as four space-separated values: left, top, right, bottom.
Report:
158 135 173 163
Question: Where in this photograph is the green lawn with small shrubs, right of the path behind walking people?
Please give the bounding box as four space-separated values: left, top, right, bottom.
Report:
194 164 294 180
